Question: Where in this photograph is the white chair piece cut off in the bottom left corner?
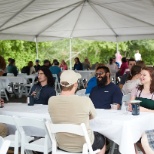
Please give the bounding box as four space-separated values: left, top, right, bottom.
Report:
0 136 10 154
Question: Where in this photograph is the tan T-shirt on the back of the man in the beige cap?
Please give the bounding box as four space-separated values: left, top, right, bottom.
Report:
49 95 95 152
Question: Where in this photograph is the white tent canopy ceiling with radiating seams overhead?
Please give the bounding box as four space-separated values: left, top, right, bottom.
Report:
0 0 154 42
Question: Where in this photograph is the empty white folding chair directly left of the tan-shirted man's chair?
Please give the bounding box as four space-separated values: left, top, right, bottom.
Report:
14 117 52 154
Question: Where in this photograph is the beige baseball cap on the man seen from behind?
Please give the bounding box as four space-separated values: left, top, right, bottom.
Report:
60 70 81 87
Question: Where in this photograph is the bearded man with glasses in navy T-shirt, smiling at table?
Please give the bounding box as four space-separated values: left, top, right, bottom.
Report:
89 66 122 109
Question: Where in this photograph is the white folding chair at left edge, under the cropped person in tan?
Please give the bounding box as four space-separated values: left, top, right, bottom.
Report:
0 115 34 154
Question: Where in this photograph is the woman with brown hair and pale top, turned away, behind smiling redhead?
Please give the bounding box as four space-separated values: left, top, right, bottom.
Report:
122 65 141 95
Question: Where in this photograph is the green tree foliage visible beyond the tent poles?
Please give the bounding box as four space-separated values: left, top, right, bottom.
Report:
0 39 154 69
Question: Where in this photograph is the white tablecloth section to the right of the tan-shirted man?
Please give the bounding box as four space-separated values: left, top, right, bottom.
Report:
90 109 154 154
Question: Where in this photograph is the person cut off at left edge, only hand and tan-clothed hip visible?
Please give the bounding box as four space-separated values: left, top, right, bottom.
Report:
0 98 8 137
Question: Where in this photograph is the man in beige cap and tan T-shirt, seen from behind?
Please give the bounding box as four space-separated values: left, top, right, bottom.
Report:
48 70 105 154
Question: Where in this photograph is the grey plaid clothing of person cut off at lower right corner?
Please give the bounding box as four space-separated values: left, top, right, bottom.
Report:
145 129 154 150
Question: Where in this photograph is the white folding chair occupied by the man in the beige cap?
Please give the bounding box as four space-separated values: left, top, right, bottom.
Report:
45 121 100 154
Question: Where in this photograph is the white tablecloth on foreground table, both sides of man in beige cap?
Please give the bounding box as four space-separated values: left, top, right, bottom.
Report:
0 103 154 154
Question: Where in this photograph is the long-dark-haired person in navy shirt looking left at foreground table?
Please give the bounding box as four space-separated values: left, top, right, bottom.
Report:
28 66 56 105
